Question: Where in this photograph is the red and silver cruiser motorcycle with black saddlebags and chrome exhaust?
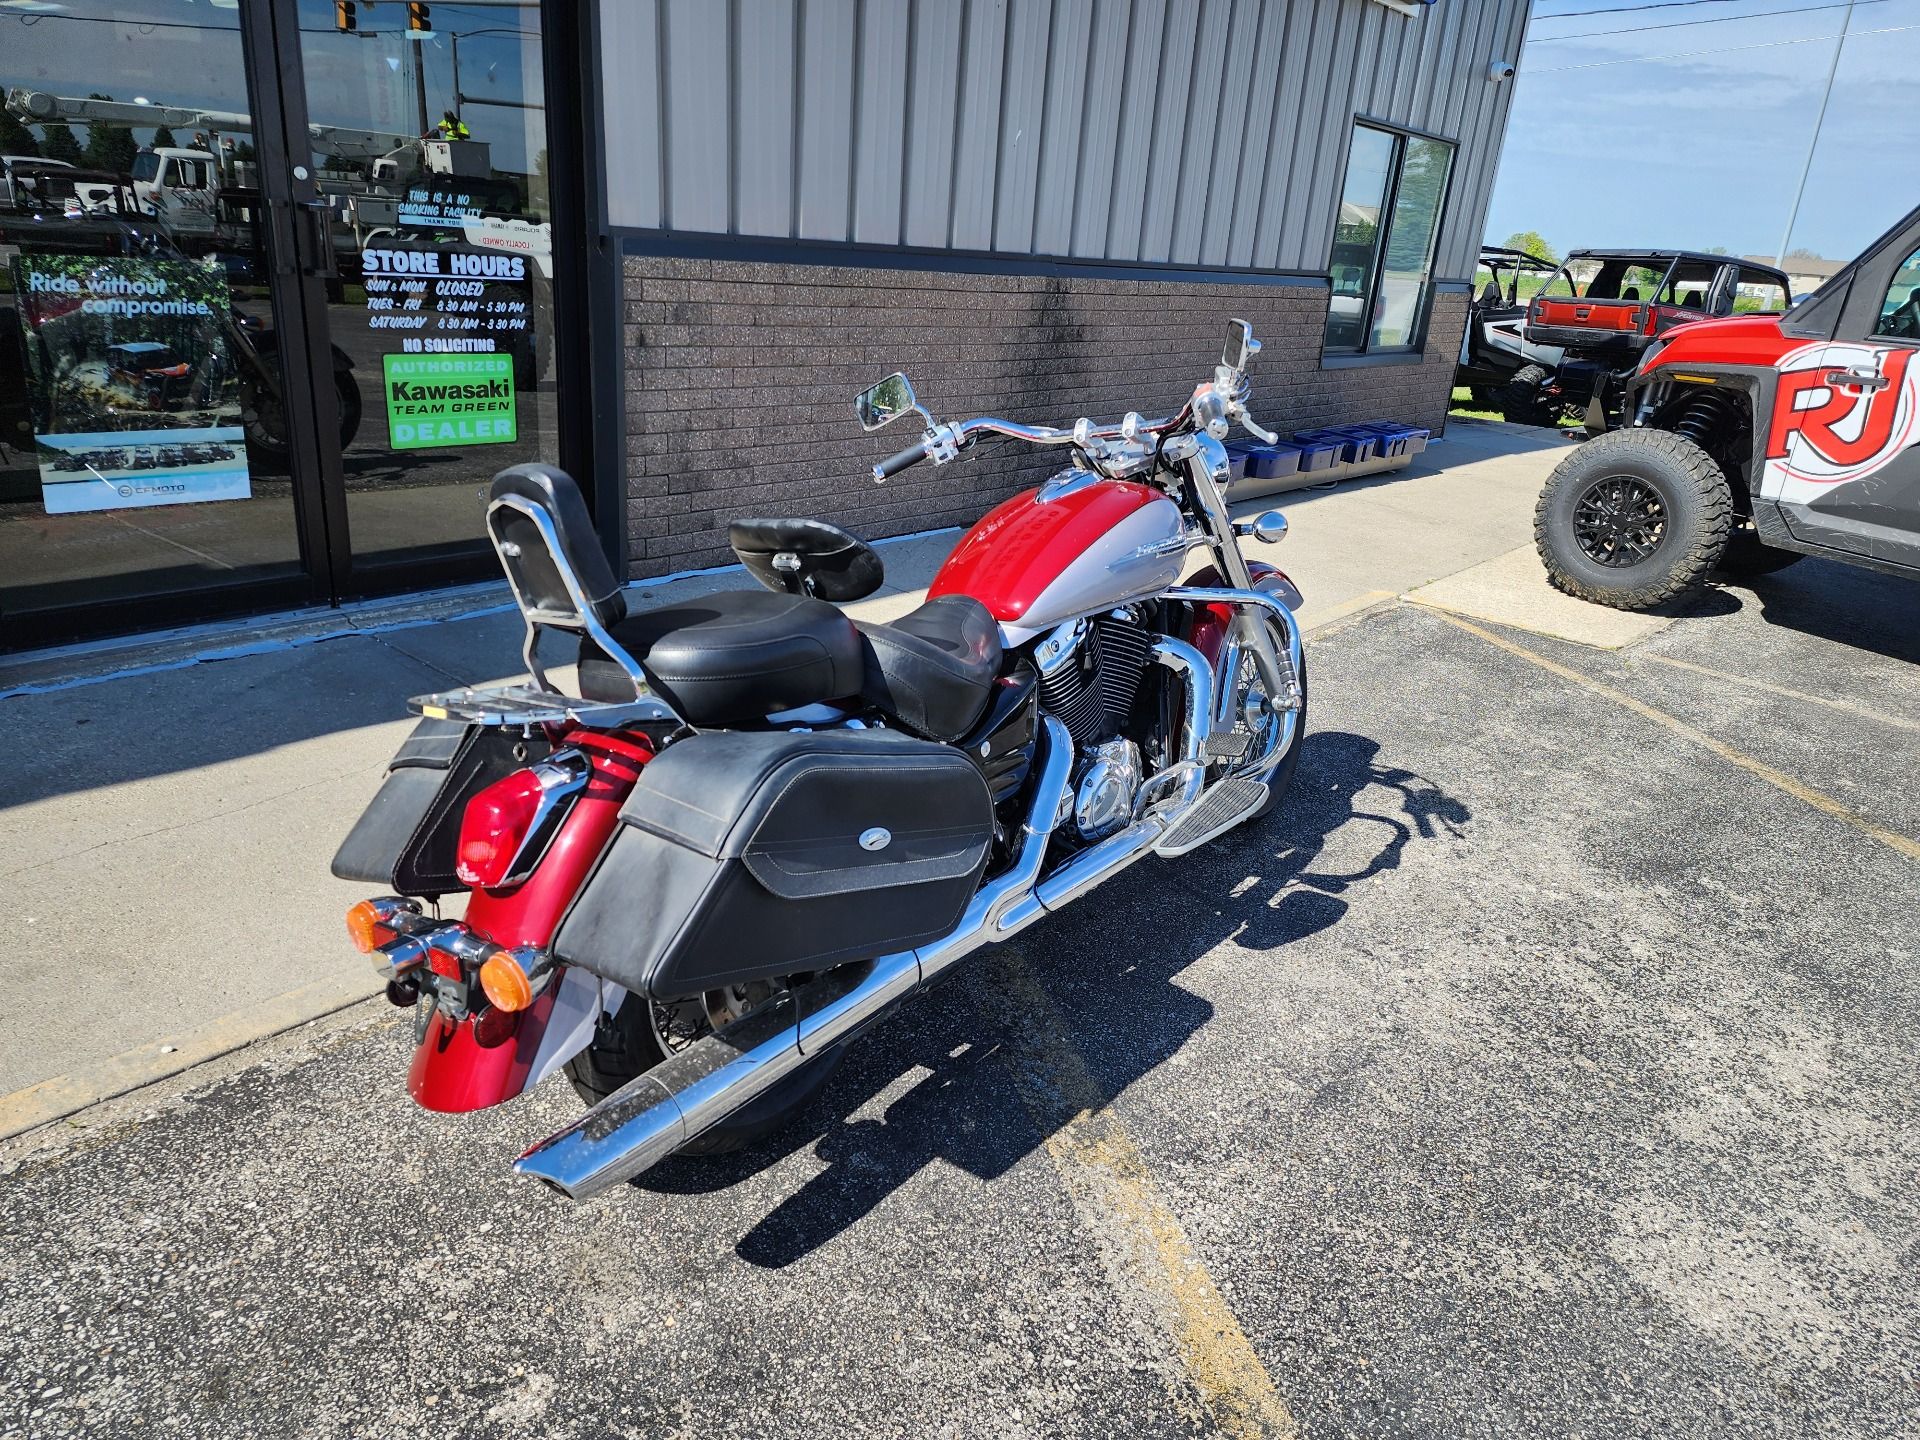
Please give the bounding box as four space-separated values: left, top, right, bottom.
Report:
334 321 1306 1198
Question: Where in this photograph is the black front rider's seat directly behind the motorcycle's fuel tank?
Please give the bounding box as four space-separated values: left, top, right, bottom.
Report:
858 595 1000 741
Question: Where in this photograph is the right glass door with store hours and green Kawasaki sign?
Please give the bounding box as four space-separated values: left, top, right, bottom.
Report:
290 0 559 593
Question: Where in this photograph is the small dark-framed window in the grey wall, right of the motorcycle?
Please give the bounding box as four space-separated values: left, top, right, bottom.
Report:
1327 125 1453 353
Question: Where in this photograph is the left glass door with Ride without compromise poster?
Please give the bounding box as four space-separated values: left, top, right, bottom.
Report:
0 0 328 649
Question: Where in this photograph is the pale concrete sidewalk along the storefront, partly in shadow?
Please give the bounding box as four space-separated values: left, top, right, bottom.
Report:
0 420 1567 1135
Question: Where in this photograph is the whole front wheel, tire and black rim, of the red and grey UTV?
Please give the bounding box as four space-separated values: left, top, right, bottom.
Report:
1534 430 1734 611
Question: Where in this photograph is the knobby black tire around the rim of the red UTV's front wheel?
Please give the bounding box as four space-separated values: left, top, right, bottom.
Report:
1534 430 1734 611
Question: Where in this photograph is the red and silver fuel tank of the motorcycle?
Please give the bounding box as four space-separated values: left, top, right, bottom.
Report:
927 472 1187 645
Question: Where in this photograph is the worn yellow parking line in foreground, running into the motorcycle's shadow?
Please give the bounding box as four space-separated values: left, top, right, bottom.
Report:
993 947 1300 1440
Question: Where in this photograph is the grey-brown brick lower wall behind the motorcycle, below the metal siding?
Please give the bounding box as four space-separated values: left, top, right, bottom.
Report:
622 257 1467 578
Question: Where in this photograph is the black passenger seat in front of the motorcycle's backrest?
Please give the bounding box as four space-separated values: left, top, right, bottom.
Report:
580 589 864 726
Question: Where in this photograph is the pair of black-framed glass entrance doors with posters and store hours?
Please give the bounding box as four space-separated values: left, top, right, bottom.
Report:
0 0 559 649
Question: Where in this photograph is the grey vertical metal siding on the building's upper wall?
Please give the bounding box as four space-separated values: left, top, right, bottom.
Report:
599 0 1528 278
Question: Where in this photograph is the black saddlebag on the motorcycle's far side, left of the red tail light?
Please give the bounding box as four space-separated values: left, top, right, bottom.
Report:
334 720 553 895
